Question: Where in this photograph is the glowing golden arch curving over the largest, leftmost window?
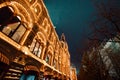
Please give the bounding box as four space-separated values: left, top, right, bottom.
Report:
0 1 33 28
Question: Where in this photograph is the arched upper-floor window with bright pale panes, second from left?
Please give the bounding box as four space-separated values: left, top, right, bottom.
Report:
30 39 42 57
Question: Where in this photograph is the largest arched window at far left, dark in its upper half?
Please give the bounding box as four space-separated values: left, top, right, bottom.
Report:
0 7 26 42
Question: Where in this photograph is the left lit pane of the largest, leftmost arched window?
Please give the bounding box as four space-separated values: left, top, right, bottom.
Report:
2 22 20 36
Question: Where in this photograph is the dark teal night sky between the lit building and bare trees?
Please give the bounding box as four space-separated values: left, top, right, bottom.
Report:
44 0 95 73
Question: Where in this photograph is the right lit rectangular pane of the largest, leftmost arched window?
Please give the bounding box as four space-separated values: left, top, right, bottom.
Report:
12 25 26 42
